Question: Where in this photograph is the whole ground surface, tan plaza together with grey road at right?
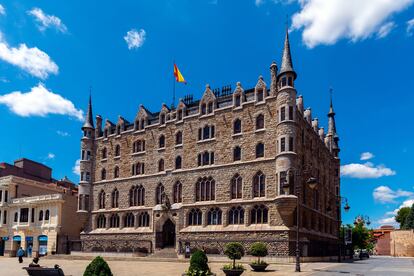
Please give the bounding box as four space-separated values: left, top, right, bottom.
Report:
0 257 414 276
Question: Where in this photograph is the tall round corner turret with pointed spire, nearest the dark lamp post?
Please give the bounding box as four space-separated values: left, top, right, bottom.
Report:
276 28 297 194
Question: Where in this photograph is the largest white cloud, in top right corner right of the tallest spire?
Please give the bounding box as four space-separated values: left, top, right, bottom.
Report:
292 0 414 48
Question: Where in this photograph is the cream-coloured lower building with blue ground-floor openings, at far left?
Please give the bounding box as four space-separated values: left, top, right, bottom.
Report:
0 159 82 256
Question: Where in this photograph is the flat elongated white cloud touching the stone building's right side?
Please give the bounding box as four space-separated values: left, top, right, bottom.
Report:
341 162 396 178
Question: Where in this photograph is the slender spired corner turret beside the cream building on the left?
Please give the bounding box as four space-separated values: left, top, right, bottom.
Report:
78 95 95 230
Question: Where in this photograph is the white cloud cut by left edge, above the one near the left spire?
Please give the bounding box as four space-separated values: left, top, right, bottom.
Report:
0 33 59 79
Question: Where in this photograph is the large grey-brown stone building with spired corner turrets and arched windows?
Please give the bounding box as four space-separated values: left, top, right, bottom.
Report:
78 30 341 256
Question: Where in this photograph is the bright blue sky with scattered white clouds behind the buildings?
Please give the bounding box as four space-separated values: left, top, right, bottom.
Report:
0 0 414 226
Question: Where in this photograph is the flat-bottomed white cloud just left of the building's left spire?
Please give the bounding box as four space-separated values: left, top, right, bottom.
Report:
0 83 83 120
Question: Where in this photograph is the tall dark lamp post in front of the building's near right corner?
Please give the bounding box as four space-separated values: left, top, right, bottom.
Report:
282 168 318 272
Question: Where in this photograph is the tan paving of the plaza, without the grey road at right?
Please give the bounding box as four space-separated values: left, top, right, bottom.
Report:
0 257 337 276
